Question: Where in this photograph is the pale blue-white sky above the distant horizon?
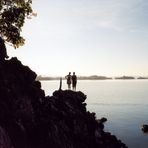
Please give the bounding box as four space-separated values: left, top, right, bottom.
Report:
7 0 148 76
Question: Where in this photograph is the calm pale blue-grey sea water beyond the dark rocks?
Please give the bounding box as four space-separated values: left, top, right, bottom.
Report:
41 80 148 148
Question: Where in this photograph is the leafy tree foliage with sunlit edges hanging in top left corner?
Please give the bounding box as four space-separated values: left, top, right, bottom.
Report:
0 0 34 48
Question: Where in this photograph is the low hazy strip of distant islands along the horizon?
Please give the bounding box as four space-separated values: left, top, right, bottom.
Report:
36 75 148 81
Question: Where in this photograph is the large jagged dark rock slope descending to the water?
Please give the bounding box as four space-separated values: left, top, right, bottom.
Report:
0 58 126 148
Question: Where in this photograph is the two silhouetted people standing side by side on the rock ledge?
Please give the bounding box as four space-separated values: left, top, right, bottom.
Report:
65 72 77 91
